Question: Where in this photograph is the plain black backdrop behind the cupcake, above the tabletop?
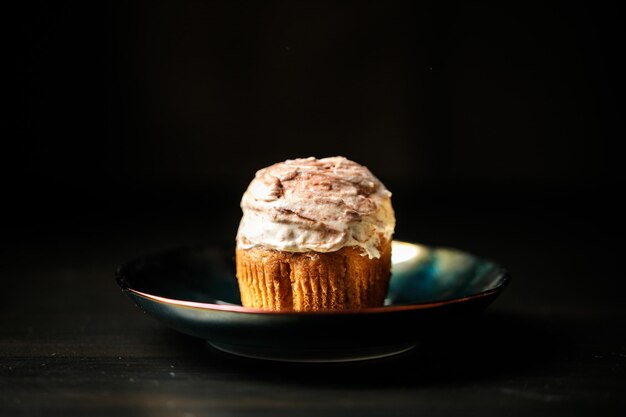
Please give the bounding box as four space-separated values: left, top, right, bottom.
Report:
3 1 624 254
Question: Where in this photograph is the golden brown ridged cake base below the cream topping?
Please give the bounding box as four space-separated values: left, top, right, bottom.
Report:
236 240 391 311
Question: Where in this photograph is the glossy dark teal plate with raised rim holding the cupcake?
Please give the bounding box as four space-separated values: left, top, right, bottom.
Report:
117 241 510 362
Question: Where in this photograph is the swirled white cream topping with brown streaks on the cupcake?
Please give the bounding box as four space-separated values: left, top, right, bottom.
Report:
237 156 395 258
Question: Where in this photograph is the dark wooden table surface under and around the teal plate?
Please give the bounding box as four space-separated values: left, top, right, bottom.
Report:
0 190 626 417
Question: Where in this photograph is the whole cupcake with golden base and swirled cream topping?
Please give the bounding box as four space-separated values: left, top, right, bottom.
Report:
236 156 395 311
